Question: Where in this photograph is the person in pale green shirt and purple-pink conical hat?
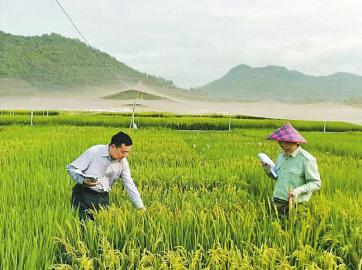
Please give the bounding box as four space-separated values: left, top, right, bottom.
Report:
263 123 321 216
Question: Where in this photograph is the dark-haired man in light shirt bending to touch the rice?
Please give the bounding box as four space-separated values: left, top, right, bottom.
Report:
67 132 145 220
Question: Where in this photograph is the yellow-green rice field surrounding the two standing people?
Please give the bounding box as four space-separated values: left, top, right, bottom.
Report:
0 116 362 269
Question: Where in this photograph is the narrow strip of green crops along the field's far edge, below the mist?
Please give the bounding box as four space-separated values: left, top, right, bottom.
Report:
0 111 362 132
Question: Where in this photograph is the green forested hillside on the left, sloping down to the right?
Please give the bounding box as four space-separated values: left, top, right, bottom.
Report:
0 31 177 94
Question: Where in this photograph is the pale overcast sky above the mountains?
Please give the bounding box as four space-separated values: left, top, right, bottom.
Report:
0 0 362 88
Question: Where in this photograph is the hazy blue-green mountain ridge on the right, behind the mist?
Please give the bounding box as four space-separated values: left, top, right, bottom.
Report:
196 65 362 101
